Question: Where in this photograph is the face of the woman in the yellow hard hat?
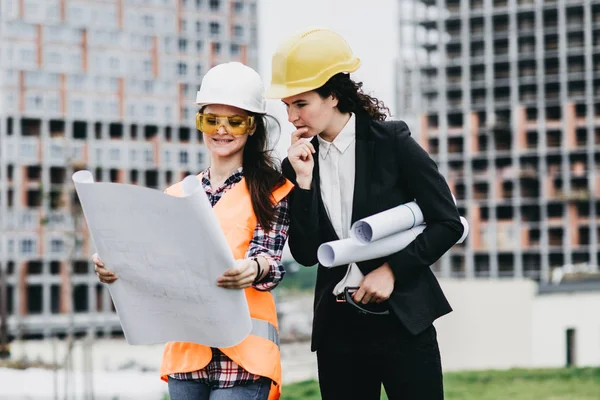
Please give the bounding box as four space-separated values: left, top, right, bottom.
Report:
282 91 338 138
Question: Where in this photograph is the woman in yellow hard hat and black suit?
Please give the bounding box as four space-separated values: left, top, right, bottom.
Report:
266 28 463 400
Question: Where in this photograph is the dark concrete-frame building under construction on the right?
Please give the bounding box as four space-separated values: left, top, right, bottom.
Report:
410 0 600 282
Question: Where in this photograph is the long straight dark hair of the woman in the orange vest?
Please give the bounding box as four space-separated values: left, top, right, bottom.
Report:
243 113 285 232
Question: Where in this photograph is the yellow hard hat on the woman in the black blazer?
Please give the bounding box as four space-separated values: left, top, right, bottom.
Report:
265 28 360 99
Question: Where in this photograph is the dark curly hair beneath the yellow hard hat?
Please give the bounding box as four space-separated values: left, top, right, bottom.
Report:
315 72 390 121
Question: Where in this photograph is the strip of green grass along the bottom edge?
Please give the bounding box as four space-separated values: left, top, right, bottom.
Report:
281 367 600 400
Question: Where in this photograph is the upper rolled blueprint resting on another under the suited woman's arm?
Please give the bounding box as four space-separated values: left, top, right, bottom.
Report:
350 201 424 243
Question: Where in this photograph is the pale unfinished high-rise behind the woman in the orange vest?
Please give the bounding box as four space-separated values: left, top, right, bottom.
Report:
0 0 257 344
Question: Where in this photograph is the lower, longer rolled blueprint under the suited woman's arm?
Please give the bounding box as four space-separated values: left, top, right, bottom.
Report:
317 217 469 267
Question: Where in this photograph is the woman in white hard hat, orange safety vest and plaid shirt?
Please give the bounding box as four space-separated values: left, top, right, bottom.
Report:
93 62 293 400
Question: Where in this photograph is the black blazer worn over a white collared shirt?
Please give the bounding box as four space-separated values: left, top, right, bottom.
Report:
282 114 463 351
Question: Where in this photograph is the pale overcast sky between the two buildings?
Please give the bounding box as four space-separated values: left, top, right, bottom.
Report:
258 0 399 158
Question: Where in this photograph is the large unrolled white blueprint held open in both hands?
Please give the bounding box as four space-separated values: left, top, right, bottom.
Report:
73 171 252 347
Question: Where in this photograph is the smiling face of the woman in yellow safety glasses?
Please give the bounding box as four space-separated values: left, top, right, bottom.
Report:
202 104 256 157
